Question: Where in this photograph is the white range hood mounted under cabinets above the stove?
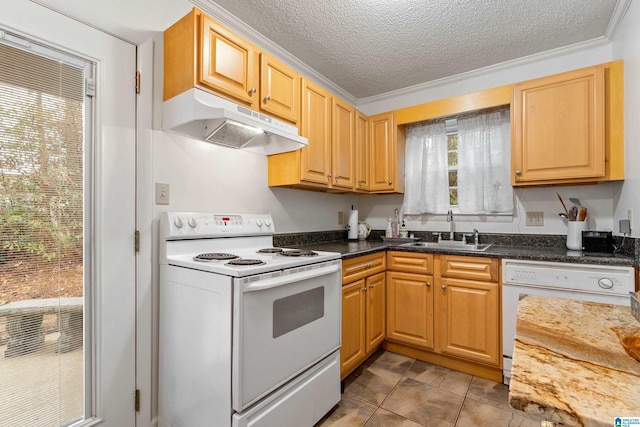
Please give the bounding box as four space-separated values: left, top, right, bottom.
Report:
162 88 308 155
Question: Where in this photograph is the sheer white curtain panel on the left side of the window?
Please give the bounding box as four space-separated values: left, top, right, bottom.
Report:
402 120 449 214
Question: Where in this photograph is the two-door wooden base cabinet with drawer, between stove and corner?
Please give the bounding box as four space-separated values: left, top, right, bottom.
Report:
340 252 386 378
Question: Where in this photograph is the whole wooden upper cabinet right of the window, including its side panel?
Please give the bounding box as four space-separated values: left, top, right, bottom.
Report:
511 61 624 186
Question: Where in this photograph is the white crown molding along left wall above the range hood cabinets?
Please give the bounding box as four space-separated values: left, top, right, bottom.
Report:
190 0 358 105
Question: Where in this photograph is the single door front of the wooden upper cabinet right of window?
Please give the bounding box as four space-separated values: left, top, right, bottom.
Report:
511 66 605 186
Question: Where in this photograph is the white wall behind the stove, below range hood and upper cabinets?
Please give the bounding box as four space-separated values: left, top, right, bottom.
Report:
152 131 350 233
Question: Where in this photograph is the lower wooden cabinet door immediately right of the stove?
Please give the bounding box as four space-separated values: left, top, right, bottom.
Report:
340 279 366 378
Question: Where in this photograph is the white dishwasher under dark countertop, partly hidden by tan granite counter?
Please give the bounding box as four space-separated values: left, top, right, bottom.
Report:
502 259 635 384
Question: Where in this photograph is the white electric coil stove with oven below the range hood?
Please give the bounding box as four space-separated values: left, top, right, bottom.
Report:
158 212 341 427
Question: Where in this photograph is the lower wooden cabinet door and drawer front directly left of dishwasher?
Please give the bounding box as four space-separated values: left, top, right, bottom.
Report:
436 255 501 366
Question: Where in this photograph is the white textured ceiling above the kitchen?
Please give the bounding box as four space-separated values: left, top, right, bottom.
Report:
208 0 616 99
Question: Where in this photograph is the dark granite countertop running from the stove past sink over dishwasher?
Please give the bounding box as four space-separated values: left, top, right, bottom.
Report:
296 240 635 267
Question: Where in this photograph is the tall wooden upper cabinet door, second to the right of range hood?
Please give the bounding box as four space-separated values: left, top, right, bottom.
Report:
331 97 356 190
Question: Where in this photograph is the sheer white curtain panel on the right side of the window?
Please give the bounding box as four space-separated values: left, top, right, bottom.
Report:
458 109 513 214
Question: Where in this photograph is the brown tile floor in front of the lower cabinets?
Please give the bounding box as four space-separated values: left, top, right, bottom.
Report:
315 350 541 427
